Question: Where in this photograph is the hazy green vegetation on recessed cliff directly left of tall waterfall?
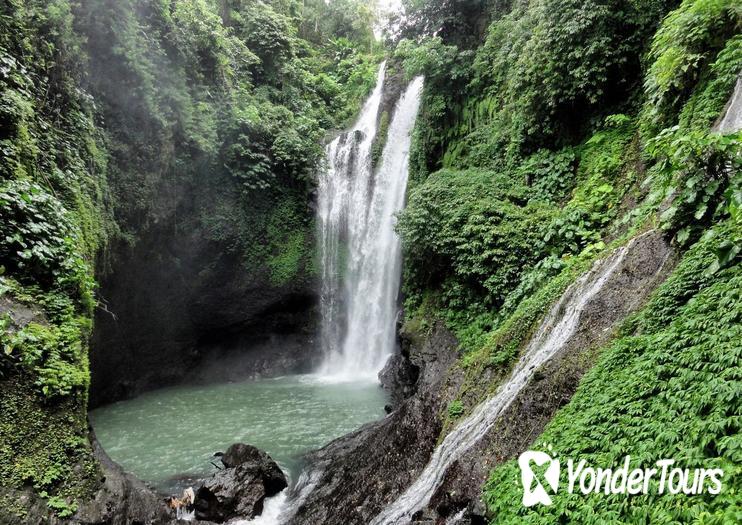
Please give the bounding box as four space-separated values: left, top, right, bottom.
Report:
76 0 380 282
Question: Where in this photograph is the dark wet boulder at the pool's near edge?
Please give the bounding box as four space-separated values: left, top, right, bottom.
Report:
195 443 287 523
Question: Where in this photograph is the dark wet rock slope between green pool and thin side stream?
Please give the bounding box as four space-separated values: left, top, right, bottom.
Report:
289 324 458 525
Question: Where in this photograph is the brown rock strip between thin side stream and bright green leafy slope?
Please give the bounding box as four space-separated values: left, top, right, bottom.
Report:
425 231 675 517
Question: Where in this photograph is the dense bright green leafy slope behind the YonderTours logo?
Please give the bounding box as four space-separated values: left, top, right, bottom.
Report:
485 224 742 523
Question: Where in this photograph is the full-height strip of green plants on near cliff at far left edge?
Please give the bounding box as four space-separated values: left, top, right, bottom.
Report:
0 2 116 516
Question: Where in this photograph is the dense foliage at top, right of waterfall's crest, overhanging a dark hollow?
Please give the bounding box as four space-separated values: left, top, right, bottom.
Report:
438 0 671 167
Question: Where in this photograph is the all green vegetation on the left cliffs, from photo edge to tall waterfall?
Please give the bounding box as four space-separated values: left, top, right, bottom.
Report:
0 0 382 517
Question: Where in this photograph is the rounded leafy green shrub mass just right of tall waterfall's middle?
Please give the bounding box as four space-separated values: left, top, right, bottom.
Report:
398 170 552 318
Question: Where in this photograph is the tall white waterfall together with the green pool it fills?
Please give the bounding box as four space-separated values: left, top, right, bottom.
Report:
90 57 422 512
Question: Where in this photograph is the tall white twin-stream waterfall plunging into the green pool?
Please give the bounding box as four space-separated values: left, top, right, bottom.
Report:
318 64 423 380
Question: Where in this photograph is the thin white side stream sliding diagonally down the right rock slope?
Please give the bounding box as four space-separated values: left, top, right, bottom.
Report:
371 241 634 525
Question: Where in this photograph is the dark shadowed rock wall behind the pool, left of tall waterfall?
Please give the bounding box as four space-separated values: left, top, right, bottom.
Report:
90 182 316 407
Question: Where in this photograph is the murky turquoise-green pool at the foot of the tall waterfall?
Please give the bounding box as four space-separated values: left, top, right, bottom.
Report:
90 376 386 493
